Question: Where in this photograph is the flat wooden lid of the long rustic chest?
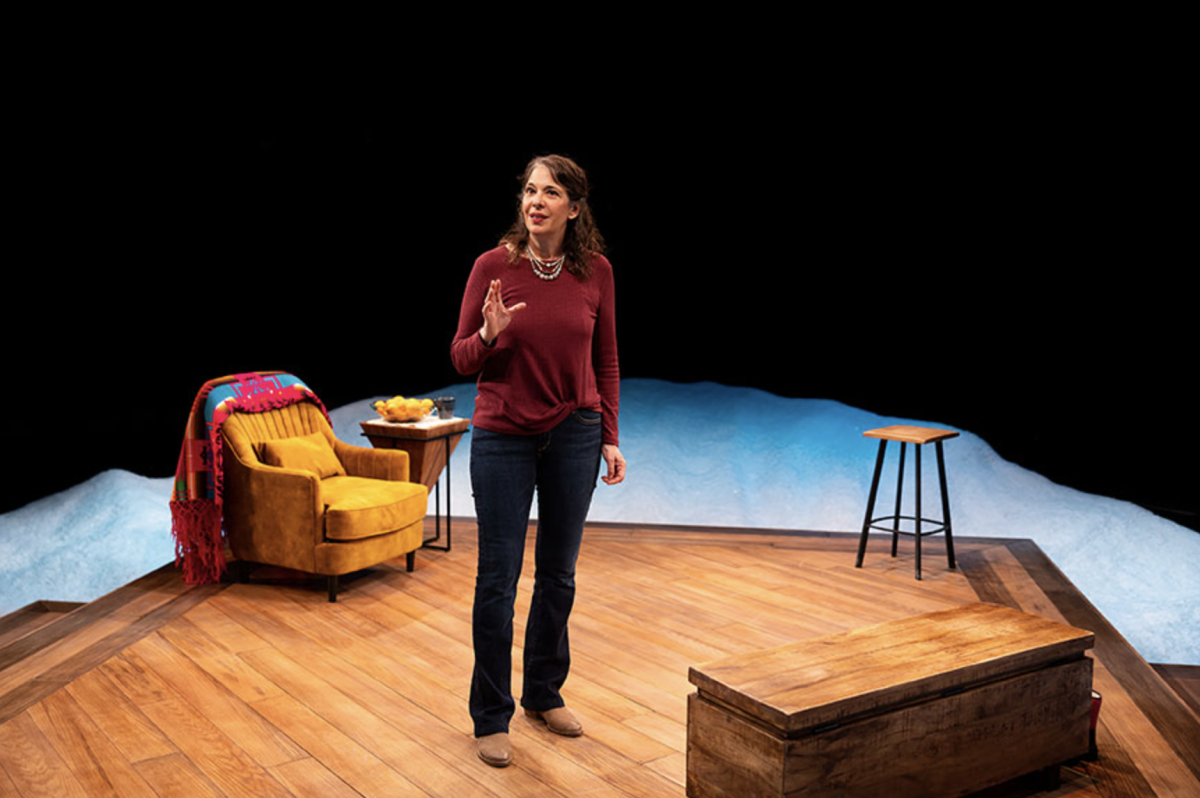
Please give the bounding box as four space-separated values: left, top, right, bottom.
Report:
689 604 1093 734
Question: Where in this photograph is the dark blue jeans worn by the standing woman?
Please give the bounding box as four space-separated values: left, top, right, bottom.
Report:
470 410 600 737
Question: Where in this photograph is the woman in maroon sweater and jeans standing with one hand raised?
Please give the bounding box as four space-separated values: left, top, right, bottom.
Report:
450 155 625 767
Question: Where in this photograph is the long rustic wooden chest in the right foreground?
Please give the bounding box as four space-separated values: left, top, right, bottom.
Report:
688 604 1093 798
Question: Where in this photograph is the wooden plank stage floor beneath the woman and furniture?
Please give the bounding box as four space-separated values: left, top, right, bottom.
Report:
0 522 1200 798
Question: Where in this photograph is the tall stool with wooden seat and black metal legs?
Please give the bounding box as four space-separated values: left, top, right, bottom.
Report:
854 425 959 580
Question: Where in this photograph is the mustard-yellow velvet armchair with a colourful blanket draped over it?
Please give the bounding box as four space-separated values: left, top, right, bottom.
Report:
221 402 428 601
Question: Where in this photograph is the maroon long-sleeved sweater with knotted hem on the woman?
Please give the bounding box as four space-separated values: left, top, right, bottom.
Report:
450 246 620 445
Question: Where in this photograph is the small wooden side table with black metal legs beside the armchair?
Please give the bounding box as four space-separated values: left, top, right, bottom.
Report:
359 419 470 551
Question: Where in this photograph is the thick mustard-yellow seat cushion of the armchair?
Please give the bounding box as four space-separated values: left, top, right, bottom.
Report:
320 476 428 540
